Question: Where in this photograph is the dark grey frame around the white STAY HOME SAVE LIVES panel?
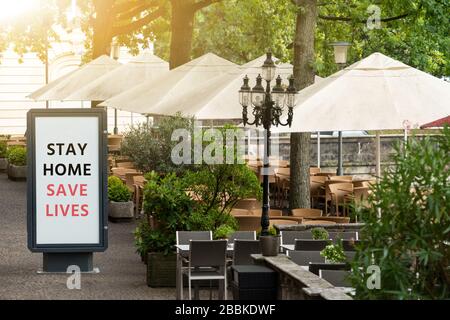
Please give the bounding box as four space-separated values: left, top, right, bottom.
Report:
26 108 108 253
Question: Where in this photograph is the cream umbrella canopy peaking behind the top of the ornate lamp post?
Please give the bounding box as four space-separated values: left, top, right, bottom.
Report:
135 55 322 120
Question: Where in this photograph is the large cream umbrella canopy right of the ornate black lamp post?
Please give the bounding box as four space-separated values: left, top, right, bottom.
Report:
276 53 450 132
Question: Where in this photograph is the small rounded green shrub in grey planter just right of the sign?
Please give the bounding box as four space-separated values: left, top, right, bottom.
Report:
108 176 134 221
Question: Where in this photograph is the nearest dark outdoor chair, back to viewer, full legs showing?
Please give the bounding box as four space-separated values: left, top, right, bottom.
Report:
183 240 227 300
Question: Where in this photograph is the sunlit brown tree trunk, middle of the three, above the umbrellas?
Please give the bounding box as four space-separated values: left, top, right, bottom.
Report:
170 0 195 69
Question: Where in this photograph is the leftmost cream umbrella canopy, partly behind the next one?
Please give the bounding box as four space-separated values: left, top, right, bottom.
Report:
29 55 121 101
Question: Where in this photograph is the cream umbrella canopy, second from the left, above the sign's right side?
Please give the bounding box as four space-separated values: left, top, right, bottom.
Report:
67 52 169 101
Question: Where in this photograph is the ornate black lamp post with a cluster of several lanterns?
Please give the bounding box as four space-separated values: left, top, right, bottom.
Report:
239 52 297 236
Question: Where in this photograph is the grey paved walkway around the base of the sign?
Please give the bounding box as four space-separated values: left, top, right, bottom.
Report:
0 173 175 300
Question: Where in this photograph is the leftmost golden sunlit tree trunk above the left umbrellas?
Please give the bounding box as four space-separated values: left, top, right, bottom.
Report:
92 0 114 60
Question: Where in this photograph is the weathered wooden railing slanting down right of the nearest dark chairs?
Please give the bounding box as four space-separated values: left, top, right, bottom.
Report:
252 254 352 300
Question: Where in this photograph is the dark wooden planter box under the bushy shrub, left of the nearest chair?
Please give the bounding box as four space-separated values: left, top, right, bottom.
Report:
147 252 177 288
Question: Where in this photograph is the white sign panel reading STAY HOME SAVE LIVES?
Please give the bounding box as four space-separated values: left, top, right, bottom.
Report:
34 116 101 246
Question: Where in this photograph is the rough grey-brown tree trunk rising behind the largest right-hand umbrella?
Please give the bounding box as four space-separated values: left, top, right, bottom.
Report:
289 0 317 209
